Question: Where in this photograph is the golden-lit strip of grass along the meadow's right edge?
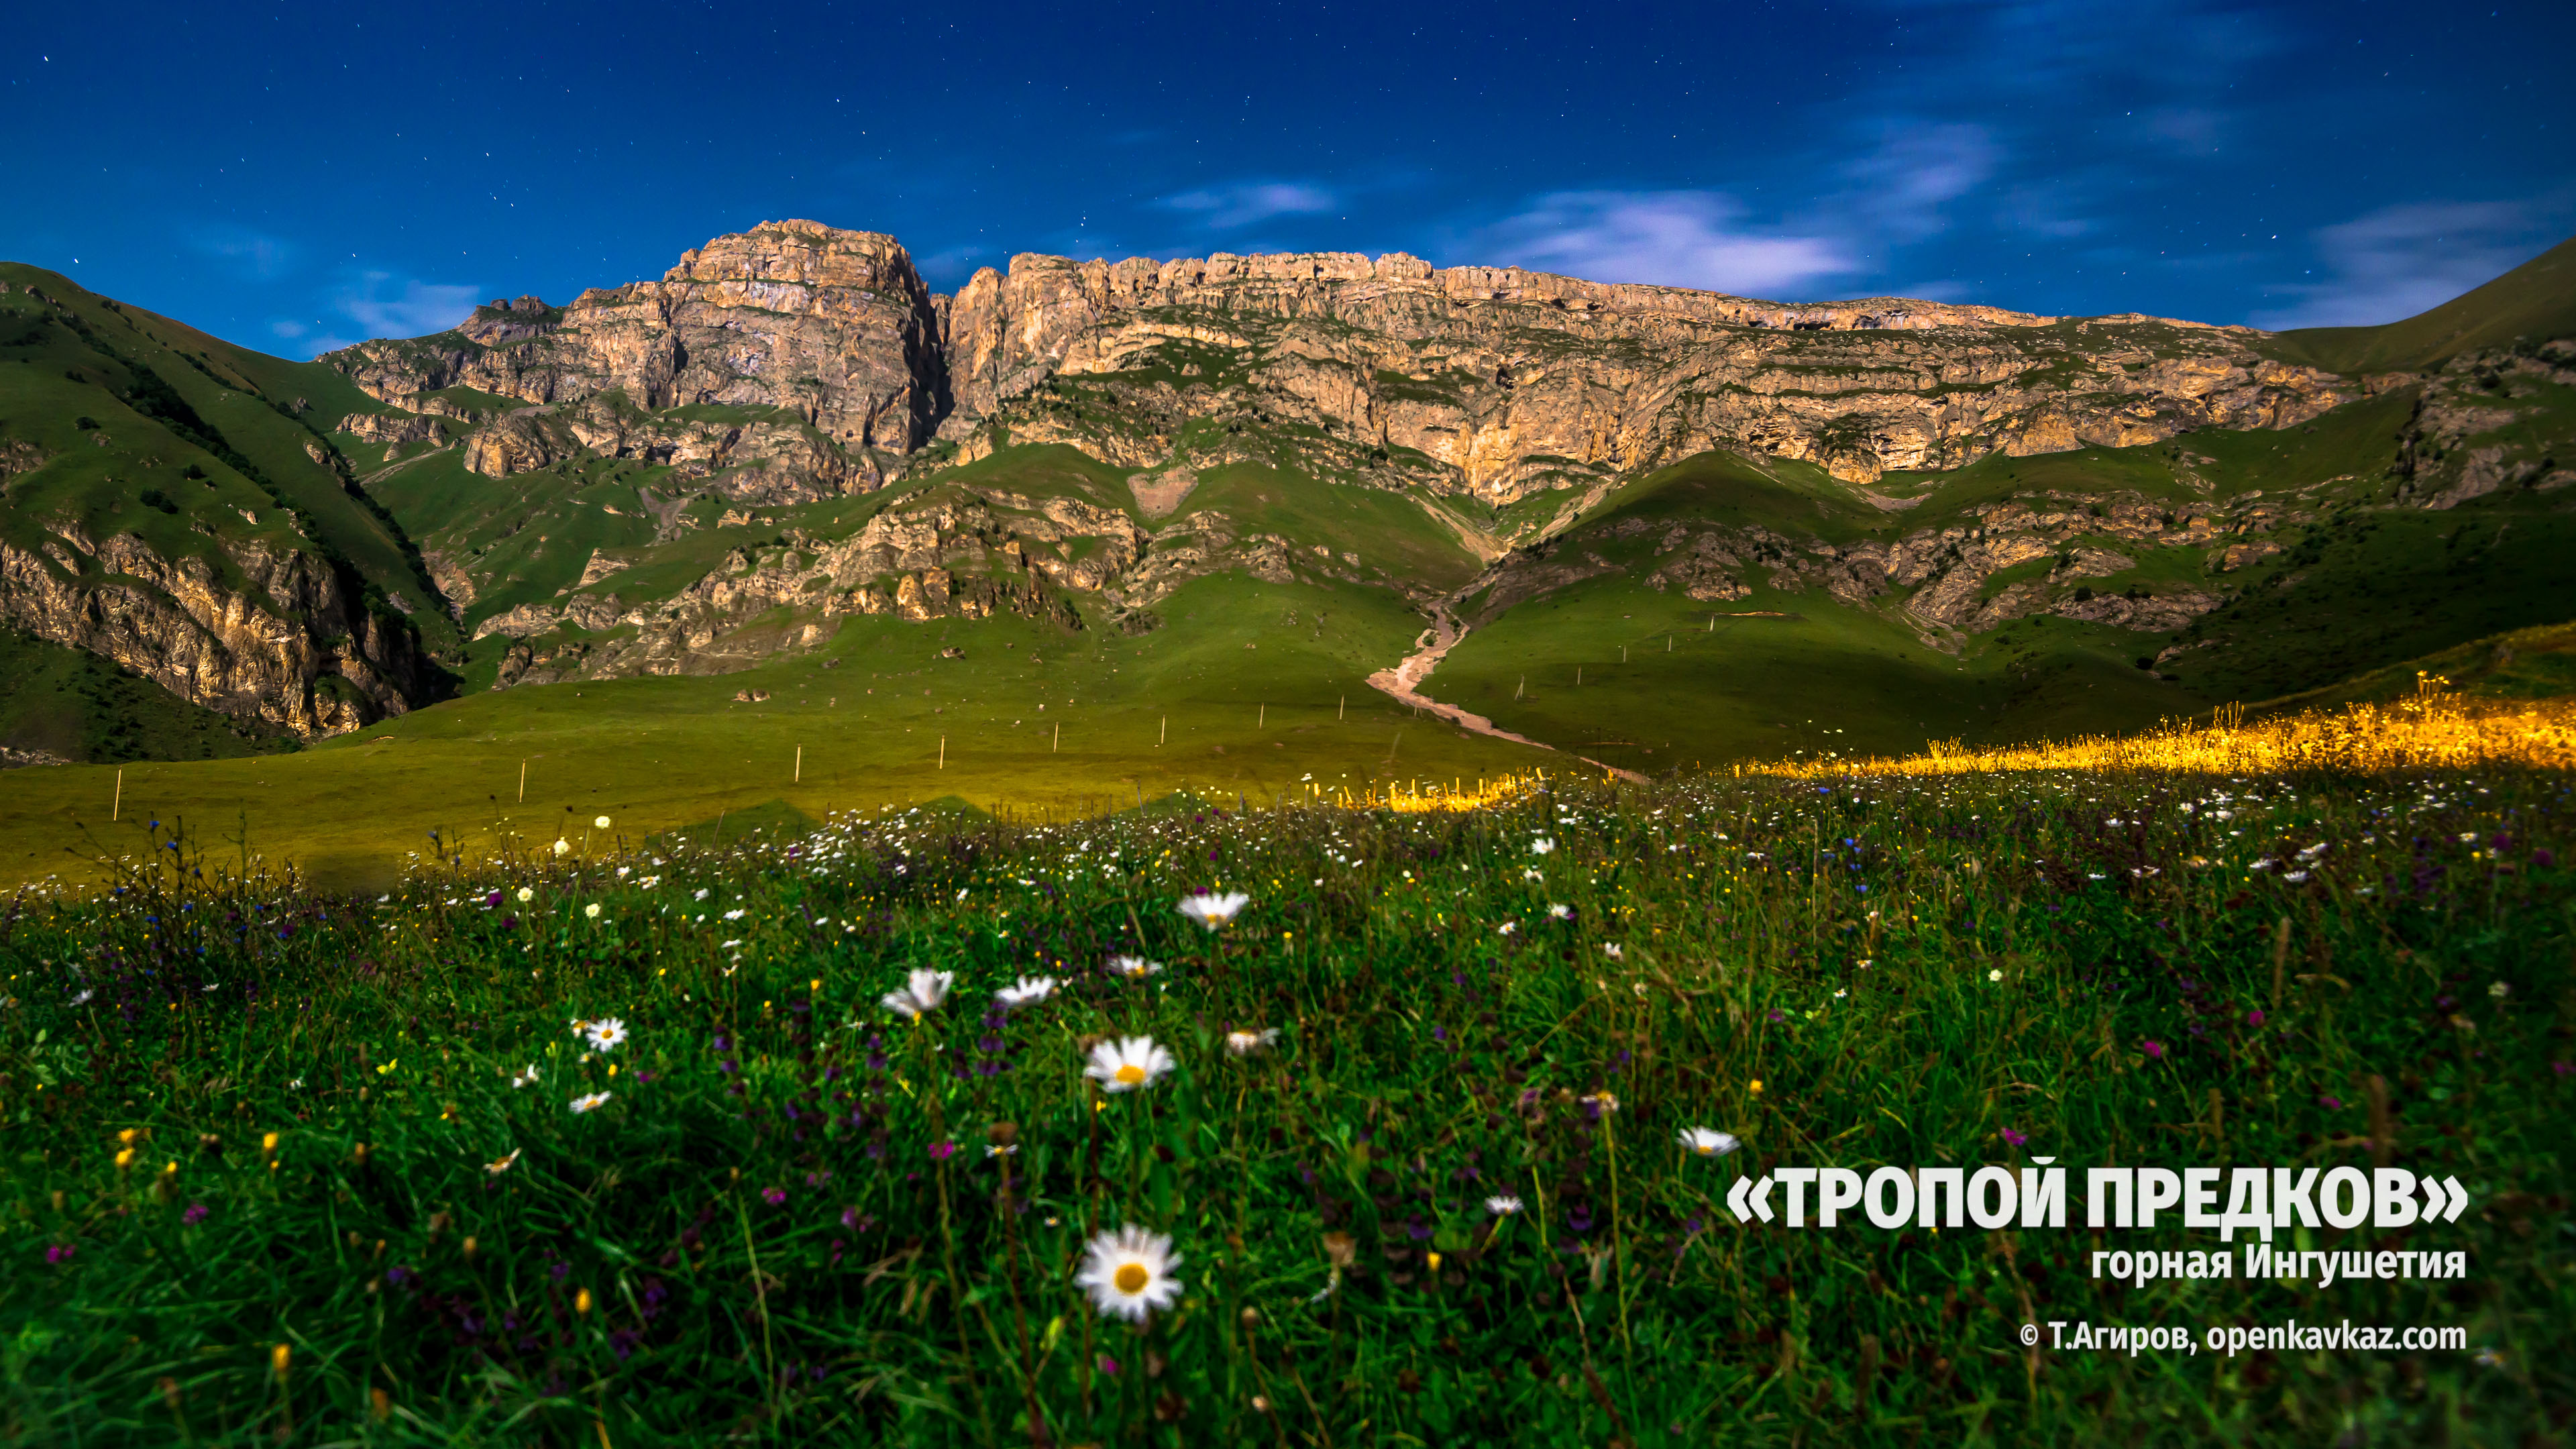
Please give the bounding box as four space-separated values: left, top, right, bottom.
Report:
1736 676 2576 779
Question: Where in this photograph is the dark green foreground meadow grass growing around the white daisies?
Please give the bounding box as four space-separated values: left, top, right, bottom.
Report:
0 771 2576 1446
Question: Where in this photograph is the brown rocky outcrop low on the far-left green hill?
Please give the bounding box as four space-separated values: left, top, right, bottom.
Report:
0 521 435 735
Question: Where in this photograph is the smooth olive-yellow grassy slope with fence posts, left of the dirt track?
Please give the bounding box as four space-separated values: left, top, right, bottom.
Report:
0 578 1566 887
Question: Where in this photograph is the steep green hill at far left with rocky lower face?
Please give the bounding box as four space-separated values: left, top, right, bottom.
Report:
0 266 459 735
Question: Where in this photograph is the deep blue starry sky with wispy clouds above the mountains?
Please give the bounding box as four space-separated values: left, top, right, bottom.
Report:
0 0 2576 356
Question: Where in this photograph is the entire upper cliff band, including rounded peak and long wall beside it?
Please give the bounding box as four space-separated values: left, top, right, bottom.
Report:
330 222 2359 502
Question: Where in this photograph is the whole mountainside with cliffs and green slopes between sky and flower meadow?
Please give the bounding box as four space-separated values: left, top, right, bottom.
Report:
0 222 2576 887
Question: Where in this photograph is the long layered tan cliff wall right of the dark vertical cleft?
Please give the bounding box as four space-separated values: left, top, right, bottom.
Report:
941 253 2362 502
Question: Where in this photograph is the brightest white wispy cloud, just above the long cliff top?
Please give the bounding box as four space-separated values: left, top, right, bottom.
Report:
1460 191 1860 297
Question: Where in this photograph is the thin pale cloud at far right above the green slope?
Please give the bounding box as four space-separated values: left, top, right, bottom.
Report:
2251 201 2540 330
